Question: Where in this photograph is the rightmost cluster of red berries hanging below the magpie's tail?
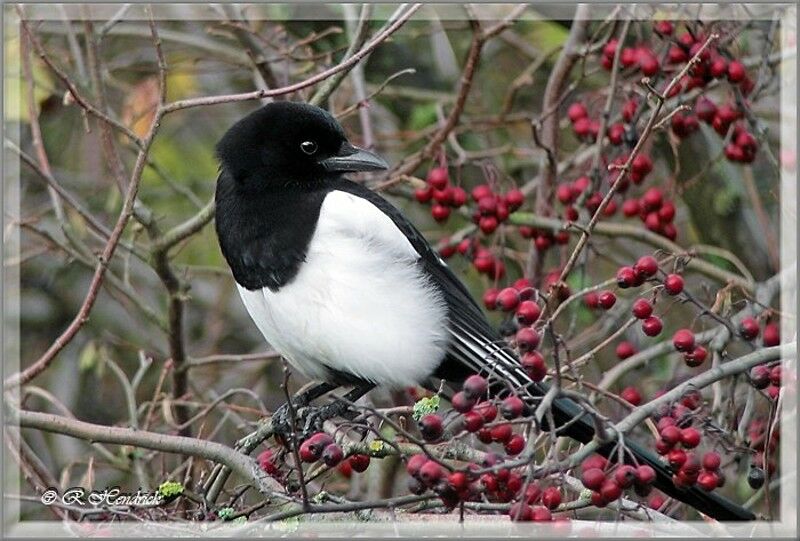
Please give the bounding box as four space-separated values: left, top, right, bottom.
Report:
580 455 656 507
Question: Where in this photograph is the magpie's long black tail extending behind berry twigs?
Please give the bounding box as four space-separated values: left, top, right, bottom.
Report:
536 384 756 521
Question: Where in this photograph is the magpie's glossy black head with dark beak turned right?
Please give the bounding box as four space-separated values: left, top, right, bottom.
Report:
212 101 388 190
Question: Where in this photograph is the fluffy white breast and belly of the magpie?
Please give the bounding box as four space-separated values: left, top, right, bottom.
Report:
239 191 447 387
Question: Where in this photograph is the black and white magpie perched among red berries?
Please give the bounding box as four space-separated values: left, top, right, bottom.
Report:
216 102 753 520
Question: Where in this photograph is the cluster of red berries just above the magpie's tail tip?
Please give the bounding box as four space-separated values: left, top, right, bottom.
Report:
656 418 725 492
